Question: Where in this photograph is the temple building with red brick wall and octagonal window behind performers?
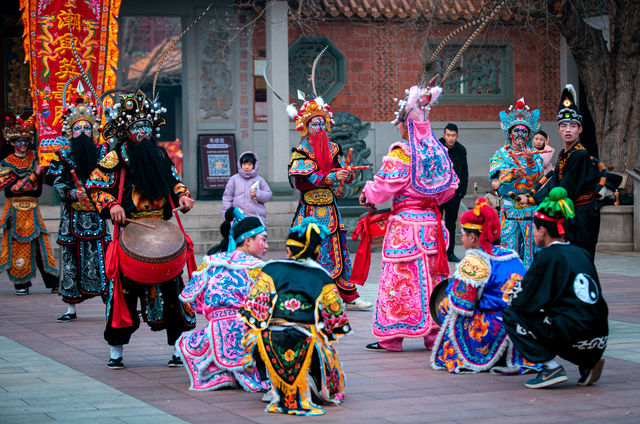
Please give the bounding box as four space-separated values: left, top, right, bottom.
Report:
0 0 579 199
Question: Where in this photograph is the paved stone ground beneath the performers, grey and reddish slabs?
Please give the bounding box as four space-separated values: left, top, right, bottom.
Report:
0 251 640 424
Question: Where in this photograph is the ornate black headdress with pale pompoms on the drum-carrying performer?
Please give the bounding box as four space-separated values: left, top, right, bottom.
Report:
102 90 167 141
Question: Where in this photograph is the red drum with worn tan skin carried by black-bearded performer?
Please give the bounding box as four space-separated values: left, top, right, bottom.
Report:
118 218 187 284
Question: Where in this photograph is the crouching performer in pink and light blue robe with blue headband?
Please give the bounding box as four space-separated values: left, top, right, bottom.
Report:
176 208 269 392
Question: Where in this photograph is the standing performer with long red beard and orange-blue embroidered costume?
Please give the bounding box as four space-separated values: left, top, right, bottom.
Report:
287 97 372 310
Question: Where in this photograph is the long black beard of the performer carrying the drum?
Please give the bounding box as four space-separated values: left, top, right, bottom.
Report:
127 140 173 200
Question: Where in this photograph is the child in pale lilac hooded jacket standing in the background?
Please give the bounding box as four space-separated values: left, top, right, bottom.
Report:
222 151 272 225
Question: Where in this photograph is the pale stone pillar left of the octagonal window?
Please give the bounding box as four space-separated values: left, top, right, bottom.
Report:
266 0 291 195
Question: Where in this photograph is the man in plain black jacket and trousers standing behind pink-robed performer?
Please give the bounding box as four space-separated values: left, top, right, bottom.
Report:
440 123 469 262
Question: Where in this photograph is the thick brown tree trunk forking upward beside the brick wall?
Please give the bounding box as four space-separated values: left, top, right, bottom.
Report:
552 0 640 172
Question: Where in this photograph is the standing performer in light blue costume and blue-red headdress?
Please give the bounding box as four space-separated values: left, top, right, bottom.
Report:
489 99 543 268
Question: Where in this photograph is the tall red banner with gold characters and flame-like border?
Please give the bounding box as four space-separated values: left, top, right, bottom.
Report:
20 0 121 166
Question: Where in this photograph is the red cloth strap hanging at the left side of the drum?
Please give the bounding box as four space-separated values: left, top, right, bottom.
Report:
105 166 133 328
